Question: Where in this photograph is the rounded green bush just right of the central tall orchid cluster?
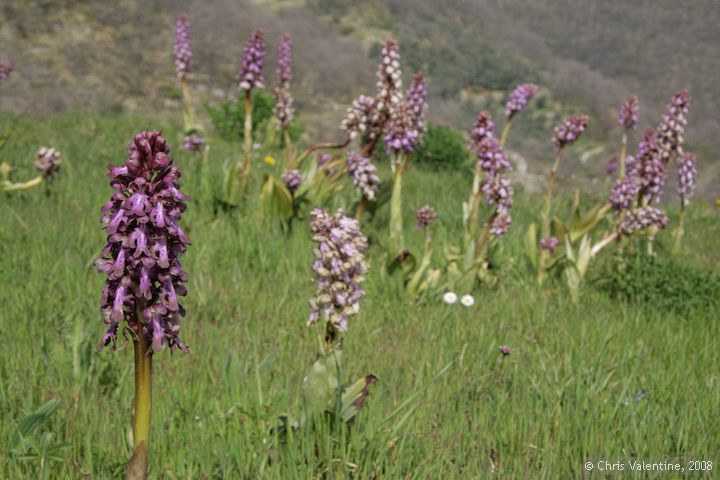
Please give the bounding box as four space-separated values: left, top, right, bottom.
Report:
413 124 468 170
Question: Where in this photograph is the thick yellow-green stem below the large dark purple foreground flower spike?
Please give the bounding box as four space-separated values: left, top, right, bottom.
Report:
125 332 152 480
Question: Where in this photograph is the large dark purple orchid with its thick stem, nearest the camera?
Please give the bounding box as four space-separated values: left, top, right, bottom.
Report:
95 131 190 480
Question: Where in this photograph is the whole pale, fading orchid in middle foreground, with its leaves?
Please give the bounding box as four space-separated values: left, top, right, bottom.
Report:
302 208 376 421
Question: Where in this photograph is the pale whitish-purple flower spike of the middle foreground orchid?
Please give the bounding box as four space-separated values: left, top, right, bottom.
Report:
308 208 368 332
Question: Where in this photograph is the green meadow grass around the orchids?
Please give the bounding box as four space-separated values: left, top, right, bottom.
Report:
0 114 720 479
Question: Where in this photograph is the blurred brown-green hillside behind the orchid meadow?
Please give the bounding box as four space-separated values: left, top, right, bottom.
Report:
0 0 720 193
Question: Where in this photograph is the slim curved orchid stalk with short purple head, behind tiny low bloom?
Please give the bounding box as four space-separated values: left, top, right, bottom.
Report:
538 115 588 283
